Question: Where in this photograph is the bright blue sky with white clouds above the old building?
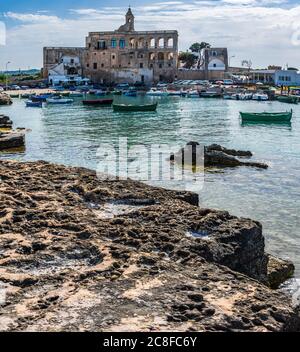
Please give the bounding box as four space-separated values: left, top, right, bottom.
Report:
0 0 300 71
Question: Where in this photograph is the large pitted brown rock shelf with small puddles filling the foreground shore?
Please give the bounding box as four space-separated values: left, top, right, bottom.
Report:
0 161 300 331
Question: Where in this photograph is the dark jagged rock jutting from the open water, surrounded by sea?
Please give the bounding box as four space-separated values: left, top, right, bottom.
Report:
170 142 268 169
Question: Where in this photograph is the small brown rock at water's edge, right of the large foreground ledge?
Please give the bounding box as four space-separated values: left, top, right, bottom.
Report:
268 255 295 289
